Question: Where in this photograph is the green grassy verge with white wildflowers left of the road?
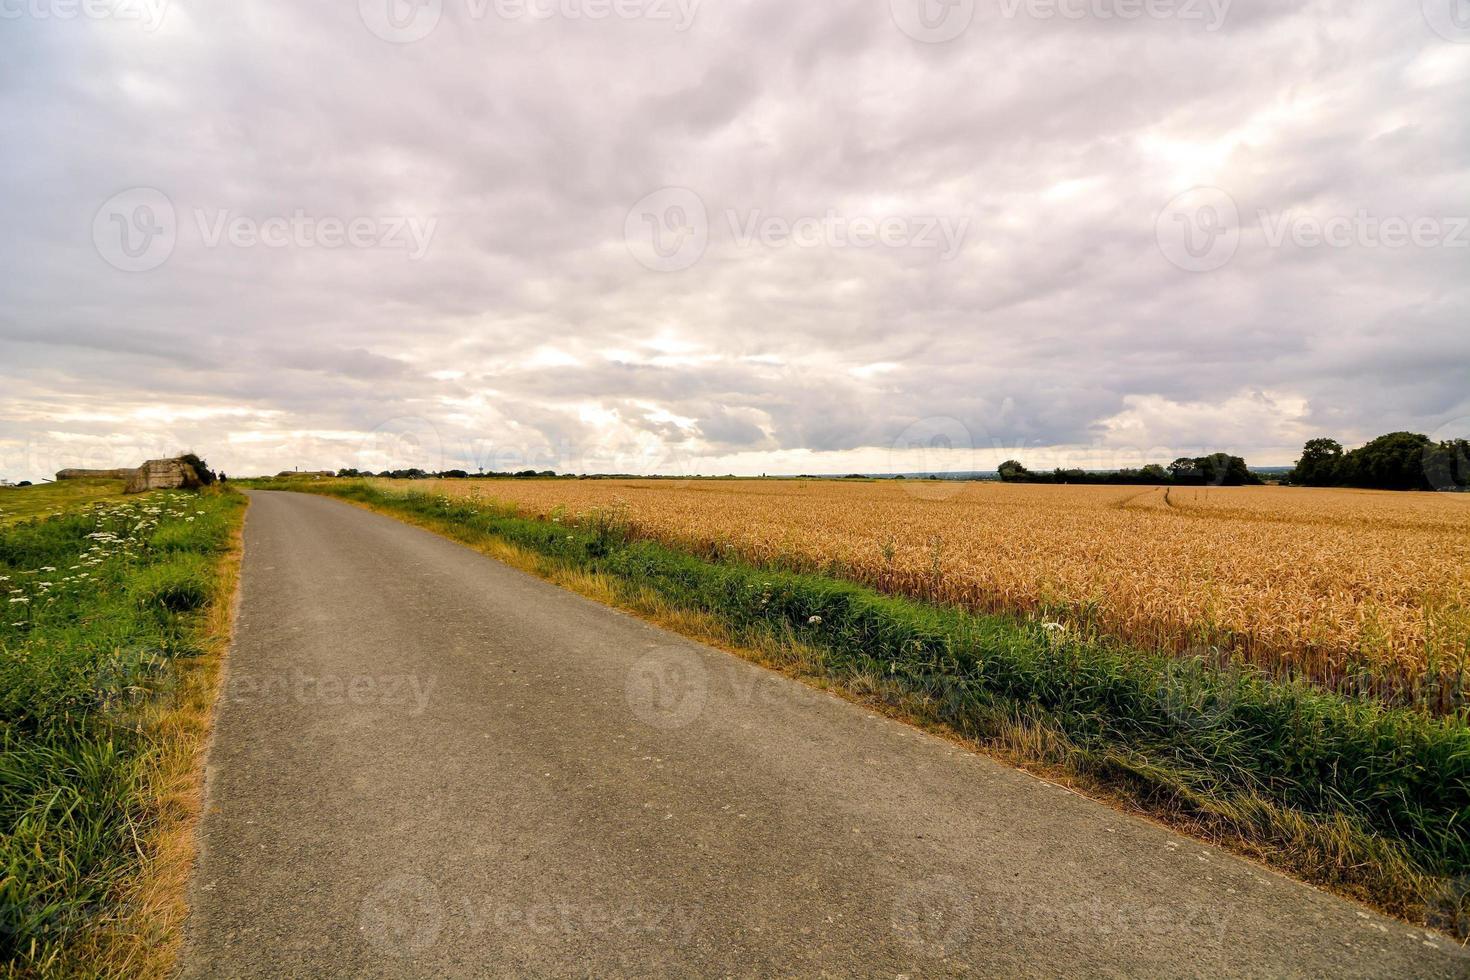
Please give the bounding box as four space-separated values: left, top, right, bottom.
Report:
0 486 244 976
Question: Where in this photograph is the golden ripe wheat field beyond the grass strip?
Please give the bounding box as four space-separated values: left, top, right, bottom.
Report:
391 480 1470 693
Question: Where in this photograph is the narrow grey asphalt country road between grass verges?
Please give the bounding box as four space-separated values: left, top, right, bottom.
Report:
182 492 1470 979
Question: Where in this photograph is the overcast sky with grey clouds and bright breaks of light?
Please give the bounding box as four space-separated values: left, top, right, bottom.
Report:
0 0 1470 479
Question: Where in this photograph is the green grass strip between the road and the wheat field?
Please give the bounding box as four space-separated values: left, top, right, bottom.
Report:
264 482 1470 932
